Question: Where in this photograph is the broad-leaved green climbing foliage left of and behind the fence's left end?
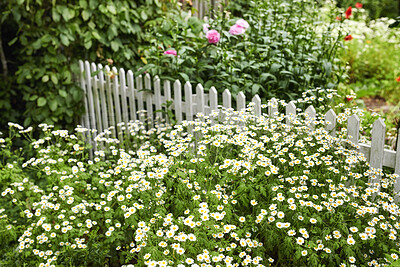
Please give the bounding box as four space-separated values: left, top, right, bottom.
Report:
0 0 182 132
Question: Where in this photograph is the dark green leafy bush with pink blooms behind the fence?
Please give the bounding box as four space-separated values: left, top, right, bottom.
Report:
143 0 342 102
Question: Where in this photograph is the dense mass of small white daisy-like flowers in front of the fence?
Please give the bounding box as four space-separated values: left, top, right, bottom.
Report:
0 90 400 266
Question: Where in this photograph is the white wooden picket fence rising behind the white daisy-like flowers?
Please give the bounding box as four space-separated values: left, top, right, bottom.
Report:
79 61 400 197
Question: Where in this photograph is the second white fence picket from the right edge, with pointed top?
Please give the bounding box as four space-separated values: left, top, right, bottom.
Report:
369 118 386 183
